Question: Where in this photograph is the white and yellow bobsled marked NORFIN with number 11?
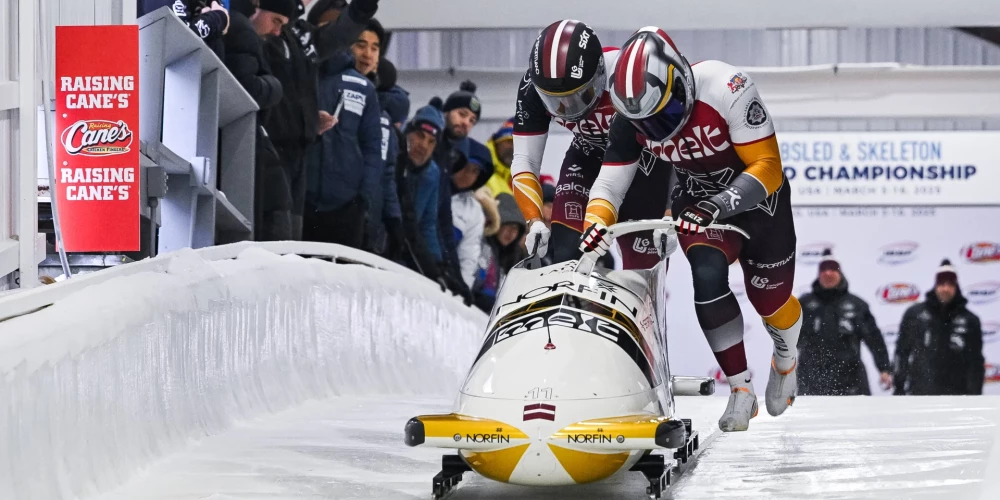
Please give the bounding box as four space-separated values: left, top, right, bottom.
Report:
404 219 738 498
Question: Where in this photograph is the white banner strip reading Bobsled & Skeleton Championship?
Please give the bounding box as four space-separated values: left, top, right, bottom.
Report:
778 132 1000 206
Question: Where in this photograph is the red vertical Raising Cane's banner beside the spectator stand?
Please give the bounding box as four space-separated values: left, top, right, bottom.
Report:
53 26 139 252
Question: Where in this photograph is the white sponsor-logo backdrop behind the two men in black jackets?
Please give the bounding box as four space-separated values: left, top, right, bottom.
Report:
667 205 1000 396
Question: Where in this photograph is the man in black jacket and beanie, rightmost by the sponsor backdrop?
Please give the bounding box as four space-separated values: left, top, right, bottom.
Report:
894 259 985 396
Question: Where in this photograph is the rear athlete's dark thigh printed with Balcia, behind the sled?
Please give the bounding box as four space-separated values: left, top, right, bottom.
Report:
549 141 604 262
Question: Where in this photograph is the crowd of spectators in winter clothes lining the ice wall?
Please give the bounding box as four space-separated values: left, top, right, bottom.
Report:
138 0 555 312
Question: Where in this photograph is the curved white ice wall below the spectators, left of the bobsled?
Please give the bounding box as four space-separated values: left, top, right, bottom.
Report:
0 249 486 500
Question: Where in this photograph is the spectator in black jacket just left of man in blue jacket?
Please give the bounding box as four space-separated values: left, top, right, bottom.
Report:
264 0 378 239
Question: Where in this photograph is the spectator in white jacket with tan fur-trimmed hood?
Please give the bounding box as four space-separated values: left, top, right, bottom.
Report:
451 138 493 288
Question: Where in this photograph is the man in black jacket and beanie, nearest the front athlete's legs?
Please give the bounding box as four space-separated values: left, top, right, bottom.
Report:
798 249 892 396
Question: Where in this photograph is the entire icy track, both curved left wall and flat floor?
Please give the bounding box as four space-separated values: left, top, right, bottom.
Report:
0 243 1000 500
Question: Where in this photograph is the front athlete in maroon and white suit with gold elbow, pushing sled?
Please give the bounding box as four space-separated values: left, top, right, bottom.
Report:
580 27 802 432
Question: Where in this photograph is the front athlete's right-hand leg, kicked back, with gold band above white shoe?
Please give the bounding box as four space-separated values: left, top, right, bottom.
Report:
740 185 802 415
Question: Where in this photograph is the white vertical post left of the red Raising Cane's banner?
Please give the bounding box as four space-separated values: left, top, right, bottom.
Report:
14 0 38 288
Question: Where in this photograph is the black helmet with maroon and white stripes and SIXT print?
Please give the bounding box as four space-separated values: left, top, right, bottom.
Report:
528 19 608 120
